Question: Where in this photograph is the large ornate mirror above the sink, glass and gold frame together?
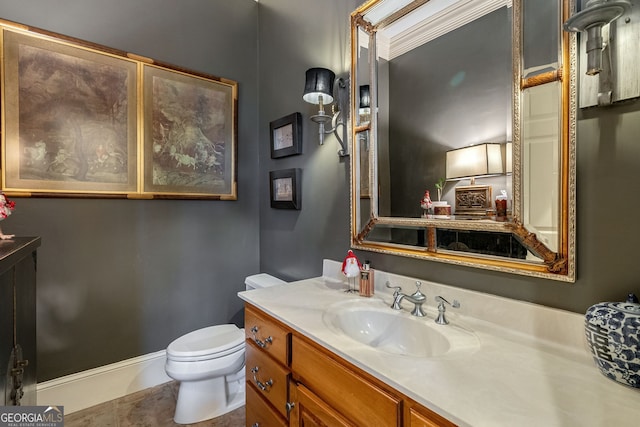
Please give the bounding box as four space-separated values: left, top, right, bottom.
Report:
350 0 576 282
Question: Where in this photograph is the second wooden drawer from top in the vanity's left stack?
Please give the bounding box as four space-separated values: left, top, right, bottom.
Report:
246 342 289 417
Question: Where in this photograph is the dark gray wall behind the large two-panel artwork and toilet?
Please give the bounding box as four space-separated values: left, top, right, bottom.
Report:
0 0 259 381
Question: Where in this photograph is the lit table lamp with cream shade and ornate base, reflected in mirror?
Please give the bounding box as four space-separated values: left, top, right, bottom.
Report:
445 143 507 216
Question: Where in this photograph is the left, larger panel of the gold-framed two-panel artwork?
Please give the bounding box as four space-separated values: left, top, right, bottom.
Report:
2 25 139 194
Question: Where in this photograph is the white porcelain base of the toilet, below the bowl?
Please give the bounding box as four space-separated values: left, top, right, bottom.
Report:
173 376 245 424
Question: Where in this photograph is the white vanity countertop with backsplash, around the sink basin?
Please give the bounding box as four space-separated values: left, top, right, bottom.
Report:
239 261 640 427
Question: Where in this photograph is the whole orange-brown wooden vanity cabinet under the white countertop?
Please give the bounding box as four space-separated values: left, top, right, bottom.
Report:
245 304 455 427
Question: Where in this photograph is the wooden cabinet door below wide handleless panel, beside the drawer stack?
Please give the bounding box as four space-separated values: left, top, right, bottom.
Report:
289 383 355 427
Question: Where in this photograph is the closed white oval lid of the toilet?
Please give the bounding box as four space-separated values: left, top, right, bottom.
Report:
167 324 244 358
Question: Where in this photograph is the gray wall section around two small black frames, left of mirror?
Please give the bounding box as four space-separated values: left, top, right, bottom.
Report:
258 0 359 280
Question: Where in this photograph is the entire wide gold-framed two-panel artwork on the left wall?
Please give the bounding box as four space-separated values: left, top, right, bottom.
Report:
0 20 238 200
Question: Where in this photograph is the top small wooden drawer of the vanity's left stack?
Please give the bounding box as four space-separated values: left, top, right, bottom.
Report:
244 305 290 366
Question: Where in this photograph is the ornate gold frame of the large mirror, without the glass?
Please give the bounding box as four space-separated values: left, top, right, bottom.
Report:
350 0 577 282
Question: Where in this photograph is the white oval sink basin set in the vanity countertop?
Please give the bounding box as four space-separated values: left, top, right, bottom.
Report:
323 298 480 357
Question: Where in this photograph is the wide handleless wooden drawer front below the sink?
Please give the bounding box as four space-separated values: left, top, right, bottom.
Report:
291 336 402 427
